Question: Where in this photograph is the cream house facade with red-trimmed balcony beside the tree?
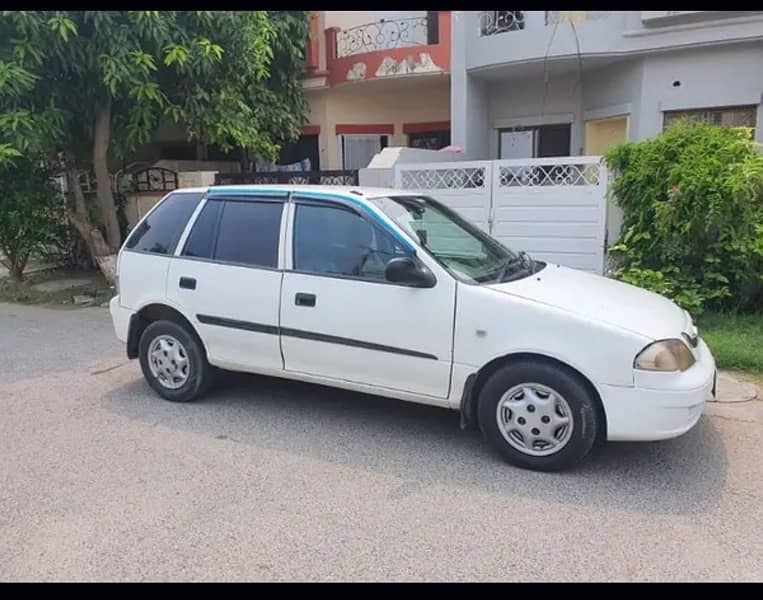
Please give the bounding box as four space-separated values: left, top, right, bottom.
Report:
298 11 451 170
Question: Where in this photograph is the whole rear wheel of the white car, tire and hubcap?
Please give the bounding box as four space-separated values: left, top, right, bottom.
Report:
138 321 212 402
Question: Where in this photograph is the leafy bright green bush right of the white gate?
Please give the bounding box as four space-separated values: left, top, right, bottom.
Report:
605 120 763 314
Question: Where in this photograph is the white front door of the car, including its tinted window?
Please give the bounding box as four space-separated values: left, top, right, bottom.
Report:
281 197 455 398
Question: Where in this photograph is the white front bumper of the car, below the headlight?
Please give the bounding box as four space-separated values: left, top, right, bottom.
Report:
599 340 716 441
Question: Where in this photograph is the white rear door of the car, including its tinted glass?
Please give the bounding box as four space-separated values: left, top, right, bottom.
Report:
167 193 286 372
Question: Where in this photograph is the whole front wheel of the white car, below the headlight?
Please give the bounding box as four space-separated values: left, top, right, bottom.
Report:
478 360 601 471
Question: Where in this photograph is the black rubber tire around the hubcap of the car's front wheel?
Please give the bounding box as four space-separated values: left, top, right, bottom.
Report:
477 359 603 471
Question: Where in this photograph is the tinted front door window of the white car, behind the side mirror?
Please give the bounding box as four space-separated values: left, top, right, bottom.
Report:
294 204 407 280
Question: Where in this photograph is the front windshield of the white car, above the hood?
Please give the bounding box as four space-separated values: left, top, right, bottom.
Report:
372 196 533 283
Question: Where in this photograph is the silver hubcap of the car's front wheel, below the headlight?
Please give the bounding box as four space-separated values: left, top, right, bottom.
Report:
496 383 572 456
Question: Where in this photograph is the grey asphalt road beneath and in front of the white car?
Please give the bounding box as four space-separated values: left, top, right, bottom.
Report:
0 304 763 581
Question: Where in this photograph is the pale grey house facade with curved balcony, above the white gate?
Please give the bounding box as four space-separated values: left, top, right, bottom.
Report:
451 11 763 159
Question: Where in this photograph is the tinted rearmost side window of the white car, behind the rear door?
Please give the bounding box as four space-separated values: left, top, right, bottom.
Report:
125 192 202 254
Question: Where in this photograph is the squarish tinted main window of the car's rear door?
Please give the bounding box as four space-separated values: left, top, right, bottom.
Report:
215 200 283 267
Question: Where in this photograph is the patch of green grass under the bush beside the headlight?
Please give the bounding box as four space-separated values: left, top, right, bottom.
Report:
699 312 763 374
